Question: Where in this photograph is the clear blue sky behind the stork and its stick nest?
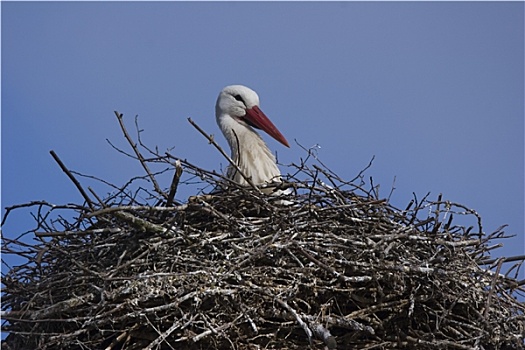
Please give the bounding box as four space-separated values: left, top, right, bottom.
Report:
1 2 524 276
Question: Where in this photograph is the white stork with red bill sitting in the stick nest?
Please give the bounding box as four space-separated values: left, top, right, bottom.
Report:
215 85 290 186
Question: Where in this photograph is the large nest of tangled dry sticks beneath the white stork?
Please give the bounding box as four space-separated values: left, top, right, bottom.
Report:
2 113 525 349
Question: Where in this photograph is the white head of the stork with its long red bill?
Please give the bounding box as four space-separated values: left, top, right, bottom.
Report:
215 85 290 147
